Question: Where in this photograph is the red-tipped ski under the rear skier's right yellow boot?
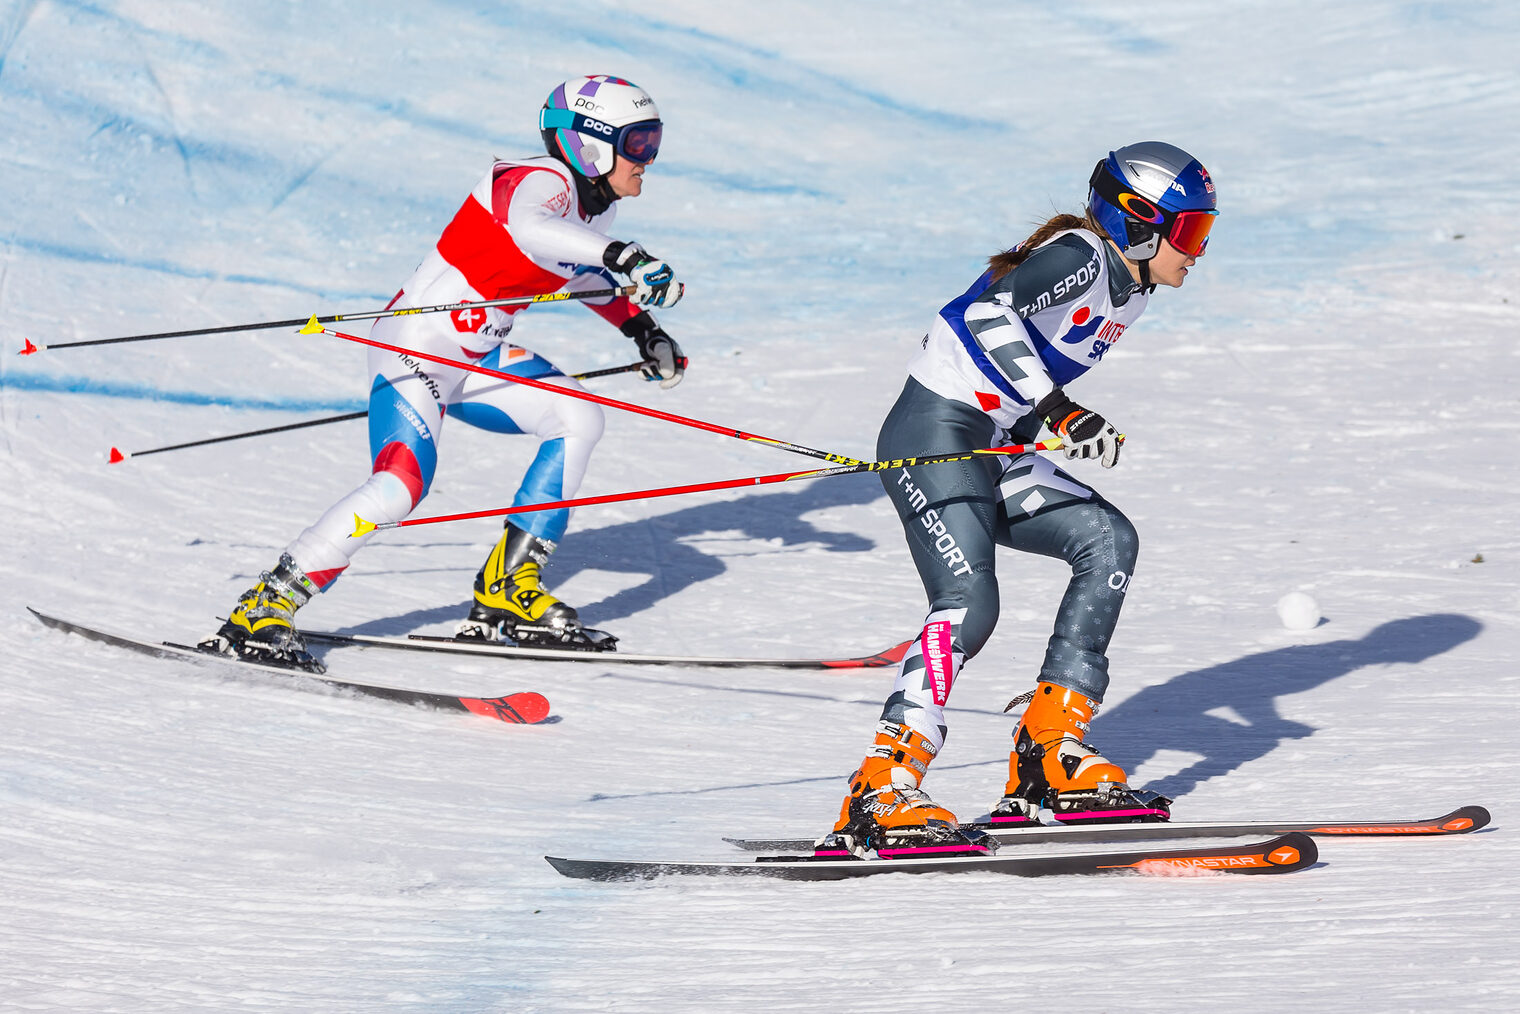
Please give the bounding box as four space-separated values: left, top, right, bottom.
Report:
301 631 912 669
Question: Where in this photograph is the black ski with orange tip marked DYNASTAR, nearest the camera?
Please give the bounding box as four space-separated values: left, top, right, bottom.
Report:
544 833 1319 880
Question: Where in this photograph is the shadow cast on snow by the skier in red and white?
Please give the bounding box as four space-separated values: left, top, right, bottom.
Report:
345 473 886 634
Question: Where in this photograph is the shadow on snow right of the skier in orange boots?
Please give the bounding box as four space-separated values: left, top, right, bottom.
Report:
1093 613 1484 798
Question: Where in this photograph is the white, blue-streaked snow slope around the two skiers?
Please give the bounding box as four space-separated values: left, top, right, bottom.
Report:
0 0 1520 1012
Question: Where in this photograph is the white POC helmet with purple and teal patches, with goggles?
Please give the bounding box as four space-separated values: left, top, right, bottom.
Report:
538 74 663 179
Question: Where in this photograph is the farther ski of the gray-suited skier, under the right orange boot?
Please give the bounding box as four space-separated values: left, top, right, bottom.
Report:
724 806 1493 851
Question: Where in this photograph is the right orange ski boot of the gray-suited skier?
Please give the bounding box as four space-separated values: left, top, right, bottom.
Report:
993 683 1172 827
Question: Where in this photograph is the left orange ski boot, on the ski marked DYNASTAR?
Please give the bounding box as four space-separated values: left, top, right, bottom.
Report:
815 722 997 859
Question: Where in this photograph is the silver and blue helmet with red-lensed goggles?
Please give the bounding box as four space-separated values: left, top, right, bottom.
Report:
1087 141 1219 260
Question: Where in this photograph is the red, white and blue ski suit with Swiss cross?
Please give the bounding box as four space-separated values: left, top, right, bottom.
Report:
286 155 638 590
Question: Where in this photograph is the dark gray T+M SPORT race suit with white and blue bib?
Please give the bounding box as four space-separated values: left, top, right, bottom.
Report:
877 230 1146 749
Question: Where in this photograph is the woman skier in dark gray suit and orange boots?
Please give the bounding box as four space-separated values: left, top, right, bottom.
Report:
819 141 1218 854
